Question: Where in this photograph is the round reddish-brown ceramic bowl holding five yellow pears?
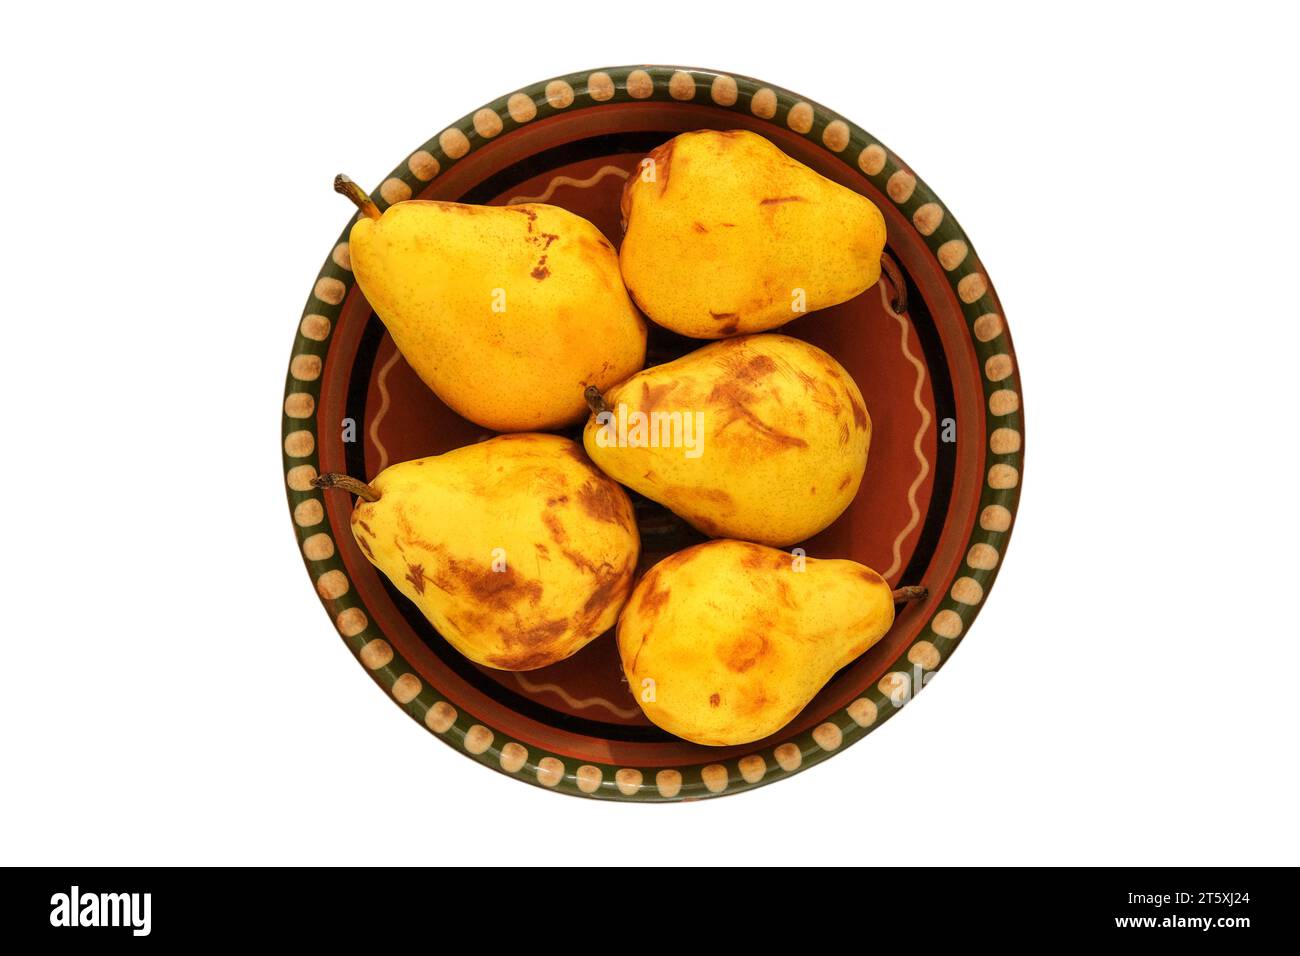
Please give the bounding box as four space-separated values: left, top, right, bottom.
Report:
283 66 1024 801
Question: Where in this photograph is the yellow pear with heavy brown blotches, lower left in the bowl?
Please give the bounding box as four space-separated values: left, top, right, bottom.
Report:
313 434 641 671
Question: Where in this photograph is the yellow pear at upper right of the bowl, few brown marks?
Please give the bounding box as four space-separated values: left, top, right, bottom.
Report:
619 130 885 338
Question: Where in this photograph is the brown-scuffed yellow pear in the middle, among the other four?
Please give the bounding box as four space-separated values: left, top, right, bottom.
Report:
582 333 871 546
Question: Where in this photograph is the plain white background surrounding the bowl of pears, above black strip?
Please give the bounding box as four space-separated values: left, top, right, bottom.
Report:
0 1 1300 865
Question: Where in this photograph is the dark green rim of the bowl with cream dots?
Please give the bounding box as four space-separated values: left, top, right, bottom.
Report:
281 65 1024 801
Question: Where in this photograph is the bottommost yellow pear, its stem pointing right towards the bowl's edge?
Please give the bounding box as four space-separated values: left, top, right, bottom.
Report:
618 541 926 747
